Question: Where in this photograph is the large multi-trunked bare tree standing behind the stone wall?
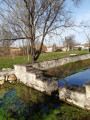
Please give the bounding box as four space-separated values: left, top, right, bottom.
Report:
0 0 80 62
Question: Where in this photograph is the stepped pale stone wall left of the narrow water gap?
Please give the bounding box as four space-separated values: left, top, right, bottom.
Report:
14 64 58 94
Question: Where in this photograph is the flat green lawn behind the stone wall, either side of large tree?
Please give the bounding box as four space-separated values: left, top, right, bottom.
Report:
0 50 89 69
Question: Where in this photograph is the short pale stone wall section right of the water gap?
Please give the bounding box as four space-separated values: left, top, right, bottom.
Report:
59 81 90 110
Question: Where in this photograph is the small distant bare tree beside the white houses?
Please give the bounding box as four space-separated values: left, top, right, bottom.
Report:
63 35 76 51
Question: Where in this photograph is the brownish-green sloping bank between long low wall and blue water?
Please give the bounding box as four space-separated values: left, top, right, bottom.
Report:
44 59 90 78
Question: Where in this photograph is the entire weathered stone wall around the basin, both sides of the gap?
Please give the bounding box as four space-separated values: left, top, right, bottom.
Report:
14 54 90 110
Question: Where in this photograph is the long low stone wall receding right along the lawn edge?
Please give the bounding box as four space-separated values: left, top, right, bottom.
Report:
33 54 90 70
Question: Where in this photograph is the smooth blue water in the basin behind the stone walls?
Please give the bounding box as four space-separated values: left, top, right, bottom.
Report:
59 69 90 87
